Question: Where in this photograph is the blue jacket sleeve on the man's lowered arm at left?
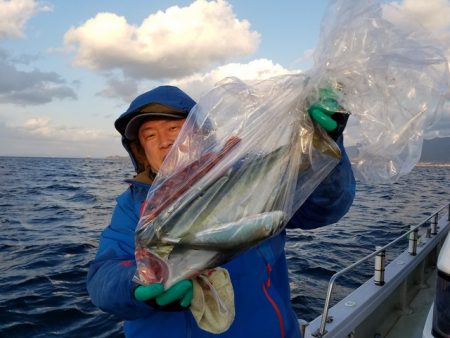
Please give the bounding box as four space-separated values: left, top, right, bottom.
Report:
87 188 153 319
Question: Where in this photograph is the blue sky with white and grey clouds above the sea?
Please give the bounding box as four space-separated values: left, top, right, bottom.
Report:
0 0 450 157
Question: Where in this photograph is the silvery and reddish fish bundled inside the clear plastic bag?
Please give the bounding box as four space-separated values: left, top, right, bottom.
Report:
135 125 340 287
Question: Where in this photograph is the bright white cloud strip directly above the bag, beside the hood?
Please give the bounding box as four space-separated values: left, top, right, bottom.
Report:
171 59 299 99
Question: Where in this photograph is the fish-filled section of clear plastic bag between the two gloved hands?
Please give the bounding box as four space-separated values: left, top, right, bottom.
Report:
136 75 340 287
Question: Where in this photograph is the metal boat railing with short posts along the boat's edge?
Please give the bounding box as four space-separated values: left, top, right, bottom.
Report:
313 203 450 337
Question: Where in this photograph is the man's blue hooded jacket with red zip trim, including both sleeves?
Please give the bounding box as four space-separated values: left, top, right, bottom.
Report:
87 86 355 338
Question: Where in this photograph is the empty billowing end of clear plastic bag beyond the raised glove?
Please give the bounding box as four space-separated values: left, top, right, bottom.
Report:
309 0 450 183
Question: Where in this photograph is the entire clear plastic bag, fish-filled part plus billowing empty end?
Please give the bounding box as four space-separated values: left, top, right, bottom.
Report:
136 0 449 286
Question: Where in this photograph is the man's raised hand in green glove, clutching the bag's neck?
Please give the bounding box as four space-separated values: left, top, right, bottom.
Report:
308 88 349 141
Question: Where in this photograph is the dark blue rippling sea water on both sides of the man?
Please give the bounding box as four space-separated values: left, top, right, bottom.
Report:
0 157 450 337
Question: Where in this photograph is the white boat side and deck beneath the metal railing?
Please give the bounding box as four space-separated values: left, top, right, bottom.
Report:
304 207 450 338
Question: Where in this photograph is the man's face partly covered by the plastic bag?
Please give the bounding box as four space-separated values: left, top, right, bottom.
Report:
139 118 186 172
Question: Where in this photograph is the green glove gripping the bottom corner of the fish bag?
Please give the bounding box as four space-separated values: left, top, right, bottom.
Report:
134 279 193 307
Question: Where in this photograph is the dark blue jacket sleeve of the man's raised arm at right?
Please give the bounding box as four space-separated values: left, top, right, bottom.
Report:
288 136 356 230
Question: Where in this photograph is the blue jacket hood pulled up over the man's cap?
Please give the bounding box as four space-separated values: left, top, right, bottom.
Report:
114 86 196 173
